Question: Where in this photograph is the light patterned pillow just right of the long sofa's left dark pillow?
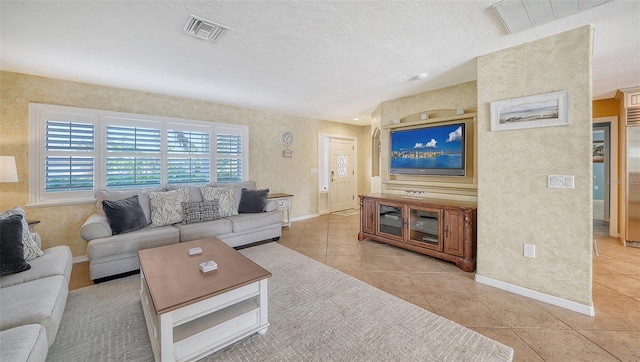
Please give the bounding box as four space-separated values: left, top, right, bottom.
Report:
149 187 189 227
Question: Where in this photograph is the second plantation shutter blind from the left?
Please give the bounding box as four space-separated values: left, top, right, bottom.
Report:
106 125 162 188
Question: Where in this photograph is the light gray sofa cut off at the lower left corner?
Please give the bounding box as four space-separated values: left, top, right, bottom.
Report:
0 234 73 361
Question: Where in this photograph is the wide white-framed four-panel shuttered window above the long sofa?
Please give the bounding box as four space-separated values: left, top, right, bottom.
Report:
29 104 249 206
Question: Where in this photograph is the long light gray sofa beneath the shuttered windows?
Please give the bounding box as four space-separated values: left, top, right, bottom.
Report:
80 181 282 281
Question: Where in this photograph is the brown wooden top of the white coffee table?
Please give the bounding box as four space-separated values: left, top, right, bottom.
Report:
138 238 271 315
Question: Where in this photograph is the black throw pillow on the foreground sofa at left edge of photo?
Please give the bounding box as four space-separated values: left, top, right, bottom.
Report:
0 215 31 275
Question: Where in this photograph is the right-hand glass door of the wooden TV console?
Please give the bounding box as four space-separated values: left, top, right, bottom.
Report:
407 206 442 251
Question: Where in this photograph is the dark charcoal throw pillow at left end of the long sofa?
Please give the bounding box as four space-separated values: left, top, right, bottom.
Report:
102 195 148 235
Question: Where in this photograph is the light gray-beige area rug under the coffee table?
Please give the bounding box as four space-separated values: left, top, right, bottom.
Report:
47 243 513 362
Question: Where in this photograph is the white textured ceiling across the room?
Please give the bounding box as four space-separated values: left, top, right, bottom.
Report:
0 0 640 124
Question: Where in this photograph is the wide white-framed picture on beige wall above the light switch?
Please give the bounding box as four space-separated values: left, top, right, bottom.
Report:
491 91 569 131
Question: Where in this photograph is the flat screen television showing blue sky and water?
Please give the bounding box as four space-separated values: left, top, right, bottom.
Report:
389 123 466 176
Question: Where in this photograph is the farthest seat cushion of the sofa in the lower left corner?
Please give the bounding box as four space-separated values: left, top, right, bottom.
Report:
0 245 73 288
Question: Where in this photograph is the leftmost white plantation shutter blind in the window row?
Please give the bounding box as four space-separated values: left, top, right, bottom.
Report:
44 120 95 192
